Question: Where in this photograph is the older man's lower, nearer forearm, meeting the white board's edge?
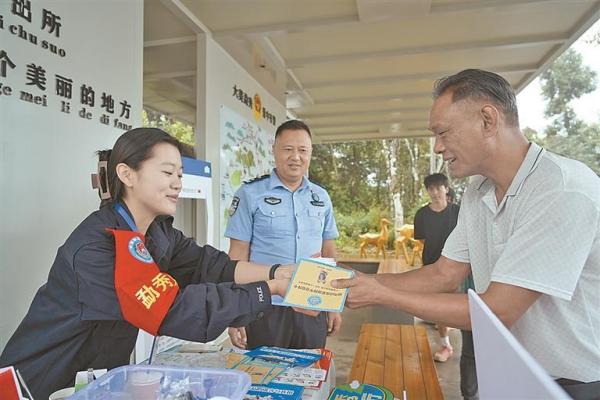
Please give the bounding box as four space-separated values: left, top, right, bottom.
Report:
377 288 471 330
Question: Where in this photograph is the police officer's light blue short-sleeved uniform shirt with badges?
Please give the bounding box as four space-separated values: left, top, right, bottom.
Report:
225 169 339 264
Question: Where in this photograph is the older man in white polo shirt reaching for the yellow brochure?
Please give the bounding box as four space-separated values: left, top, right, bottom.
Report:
337 70 600 399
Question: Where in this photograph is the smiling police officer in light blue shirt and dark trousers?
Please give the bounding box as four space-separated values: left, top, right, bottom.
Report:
225 120 341 348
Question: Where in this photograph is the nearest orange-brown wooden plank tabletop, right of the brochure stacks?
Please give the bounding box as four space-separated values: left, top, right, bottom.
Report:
348 324 444 400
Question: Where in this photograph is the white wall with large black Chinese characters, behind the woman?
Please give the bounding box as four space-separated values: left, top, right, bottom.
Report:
0 0 143 350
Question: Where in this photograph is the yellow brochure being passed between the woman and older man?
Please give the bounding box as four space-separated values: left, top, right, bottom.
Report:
282 259 354 312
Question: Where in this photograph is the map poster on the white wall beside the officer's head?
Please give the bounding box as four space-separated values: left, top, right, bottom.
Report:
220 106 275 251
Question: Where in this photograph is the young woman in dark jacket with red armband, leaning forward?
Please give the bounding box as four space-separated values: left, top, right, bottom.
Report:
0 128 290 399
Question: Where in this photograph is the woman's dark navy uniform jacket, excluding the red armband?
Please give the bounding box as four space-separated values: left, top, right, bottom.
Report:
0 206 271 399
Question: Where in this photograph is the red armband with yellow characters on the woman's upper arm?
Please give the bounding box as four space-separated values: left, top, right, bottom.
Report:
107 229 179 335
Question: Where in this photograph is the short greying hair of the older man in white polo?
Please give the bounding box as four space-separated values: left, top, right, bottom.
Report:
433 69 519 126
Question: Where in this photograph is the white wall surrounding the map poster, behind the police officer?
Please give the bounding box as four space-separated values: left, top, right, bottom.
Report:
196 35 286 250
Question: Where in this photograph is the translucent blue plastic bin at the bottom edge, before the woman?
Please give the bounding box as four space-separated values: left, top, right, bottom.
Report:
69 365 250 400
